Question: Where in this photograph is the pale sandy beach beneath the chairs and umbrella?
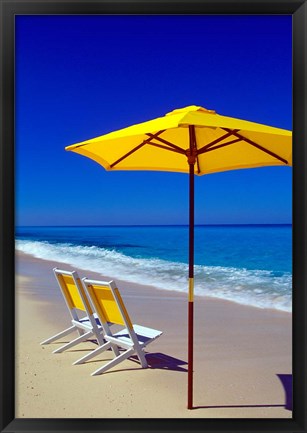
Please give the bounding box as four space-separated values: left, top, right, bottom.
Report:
15 253 292 418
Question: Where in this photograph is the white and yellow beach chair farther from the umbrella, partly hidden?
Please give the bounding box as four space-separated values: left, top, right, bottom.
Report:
40 268 105 353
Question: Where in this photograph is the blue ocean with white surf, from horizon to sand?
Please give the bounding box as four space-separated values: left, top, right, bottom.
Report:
16 225 292 312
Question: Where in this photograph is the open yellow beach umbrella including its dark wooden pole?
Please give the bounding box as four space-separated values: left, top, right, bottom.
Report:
66 105 292 409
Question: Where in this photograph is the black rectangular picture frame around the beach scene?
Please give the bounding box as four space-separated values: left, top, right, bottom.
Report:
0 0 307 433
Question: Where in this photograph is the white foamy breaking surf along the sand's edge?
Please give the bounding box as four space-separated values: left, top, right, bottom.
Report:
16 240 292 312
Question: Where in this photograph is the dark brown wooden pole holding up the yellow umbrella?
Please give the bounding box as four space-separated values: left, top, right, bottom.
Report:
188 127 195 409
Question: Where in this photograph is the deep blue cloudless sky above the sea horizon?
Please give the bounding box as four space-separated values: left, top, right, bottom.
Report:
15 15 292 225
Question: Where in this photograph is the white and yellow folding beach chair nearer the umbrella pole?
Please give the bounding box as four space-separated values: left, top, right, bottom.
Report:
74 278 162 376
